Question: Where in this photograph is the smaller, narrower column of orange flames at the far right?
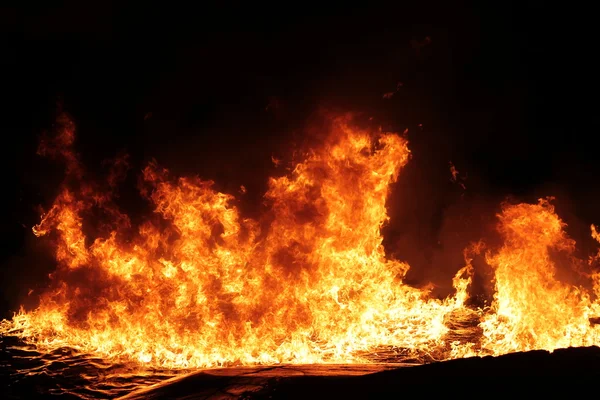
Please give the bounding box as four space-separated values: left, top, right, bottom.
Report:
481 199 600 354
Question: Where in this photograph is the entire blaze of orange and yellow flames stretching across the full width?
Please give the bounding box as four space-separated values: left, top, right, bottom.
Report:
0 112 600 368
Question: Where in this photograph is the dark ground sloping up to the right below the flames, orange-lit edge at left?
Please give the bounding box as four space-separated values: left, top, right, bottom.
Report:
122 347 600 400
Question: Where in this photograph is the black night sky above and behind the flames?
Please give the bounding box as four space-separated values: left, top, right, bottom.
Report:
0 1 600 316
